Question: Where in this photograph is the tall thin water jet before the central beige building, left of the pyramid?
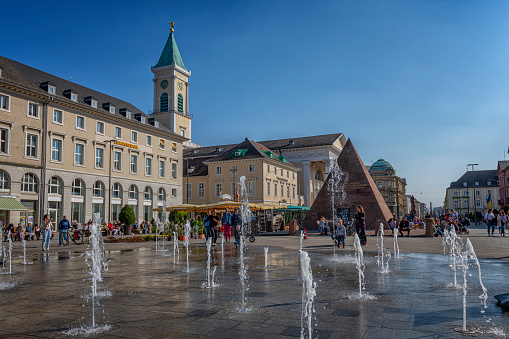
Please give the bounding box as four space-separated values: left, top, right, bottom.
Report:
237 176 251 312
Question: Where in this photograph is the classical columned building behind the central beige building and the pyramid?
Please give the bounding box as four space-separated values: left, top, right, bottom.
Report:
184 133 346 207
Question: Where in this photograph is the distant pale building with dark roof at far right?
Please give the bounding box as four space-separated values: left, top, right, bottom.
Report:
444 170 500 216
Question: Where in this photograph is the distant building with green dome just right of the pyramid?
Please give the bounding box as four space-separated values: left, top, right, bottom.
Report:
366 159 407 217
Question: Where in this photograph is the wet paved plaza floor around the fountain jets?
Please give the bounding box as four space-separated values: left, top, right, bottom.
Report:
0 228 509 338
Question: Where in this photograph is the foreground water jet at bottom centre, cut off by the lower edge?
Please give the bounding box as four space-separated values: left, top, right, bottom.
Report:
300 251 316 339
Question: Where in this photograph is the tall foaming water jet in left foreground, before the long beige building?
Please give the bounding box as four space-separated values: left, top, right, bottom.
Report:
87 213 108 327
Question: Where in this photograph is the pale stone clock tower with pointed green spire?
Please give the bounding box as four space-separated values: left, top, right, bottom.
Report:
151 21 192 146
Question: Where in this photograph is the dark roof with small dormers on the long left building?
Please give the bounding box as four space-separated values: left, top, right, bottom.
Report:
0 56 178 136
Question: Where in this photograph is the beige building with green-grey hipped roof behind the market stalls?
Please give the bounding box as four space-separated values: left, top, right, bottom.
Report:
184 139 299 205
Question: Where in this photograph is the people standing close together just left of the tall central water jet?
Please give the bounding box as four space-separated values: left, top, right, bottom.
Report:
203 208 242 246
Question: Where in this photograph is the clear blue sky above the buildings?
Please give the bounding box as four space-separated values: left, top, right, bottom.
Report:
0 0 509 206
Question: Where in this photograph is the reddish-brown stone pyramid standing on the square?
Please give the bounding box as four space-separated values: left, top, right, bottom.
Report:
303 139 392 230
